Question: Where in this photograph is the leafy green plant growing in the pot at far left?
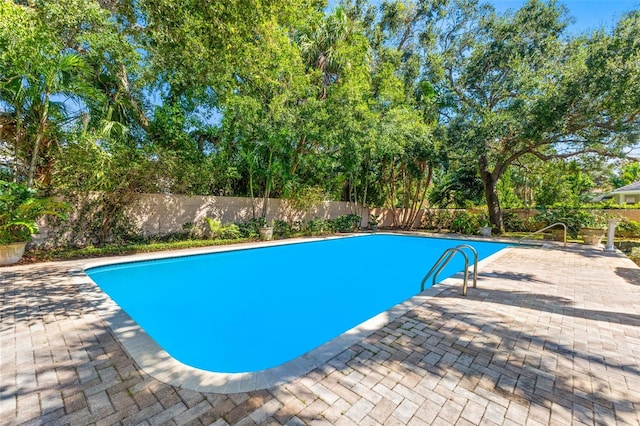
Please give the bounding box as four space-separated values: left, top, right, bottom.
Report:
0 181 69 244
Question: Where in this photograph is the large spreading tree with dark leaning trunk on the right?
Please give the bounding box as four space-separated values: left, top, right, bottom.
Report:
424 0 640 233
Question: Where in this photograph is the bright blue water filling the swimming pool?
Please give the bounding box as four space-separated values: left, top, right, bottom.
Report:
87 235 506 373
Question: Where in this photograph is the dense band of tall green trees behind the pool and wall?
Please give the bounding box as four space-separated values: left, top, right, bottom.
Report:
0 0 640 250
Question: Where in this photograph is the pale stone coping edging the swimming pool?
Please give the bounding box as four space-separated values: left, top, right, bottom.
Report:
74 232 513 394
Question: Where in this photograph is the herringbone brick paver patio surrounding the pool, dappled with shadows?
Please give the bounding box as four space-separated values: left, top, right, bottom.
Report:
0 241 640 425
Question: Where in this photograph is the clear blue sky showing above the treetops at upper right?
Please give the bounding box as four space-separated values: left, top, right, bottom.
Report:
329 0 640 34
